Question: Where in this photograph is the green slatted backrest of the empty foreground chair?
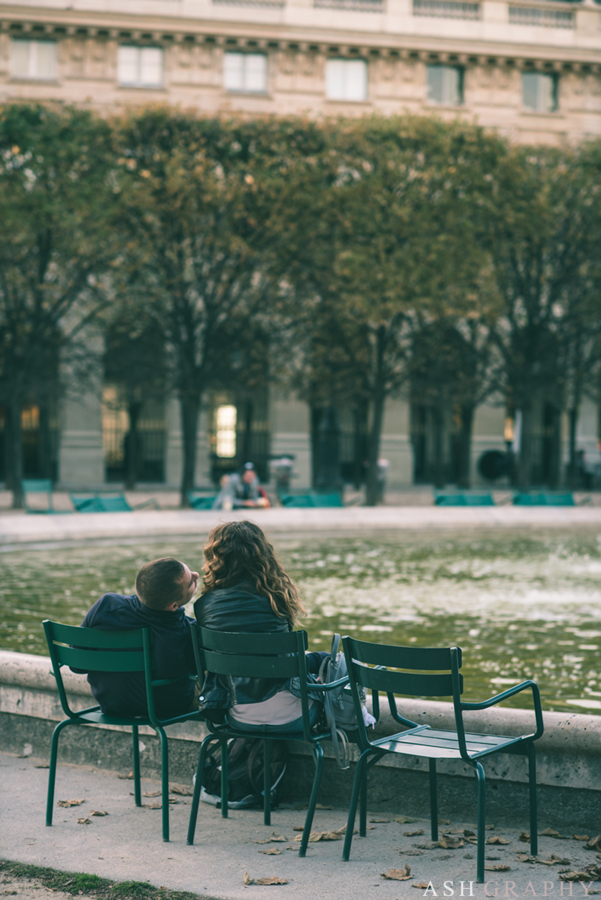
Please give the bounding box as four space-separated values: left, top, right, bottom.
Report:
342 637 463 744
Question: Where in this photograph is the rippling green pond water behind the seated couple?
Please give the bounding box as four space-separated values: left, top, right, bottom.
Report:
0 532 601 713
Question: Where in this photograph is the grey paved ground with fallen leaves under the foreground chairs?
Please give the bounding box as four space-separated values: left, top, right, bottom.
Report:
0 754 601 900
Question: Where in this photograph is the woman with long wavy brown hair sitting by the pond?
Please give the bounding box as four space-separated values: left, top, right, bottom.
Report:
194 522 328 732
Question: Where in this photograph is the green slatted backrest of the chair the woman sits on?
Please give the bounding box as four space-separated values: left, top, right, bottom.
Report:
192 624 311 740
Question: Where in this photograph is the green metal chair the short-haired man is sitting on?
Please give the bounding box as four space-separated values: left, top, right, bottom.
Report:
42 619 202 841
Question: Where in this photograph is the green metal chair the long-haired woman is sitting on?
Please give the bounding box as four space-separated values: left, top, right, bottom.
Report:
188 625 348 856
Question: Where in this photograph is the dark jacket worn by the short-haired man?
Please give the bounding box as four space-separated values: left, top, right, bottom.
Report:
81 594 195 719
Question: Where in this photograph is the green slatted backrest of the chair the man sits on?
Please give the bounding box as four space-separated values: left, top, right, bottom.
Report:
42 619 159 723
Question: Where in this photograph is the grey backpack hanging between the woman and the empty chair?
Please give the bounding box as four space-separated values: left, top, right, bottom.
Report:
317 634 365 769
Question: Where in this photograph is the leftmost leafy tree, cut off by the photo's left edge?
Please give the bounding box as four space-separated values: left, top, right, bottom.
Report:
0 105 114 507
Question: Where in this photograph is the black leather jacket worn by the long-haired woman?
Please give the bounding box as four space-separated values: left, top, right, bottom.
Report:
194 582 292 711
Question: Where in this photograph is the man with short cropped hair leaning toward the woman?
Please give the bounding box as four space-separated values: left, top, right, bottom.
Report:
81 556 198 718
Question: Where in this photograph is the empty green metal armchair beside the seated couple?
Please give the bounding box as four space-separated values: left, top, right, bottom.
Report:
342 637 544 883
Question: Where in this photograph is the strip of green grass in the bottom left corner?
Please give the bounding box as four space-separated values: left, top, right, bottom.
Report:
0 860 213 900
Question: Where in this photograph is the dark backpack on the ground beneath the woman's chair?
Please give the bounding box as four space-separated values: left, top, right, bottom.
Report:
200 738 288 809
